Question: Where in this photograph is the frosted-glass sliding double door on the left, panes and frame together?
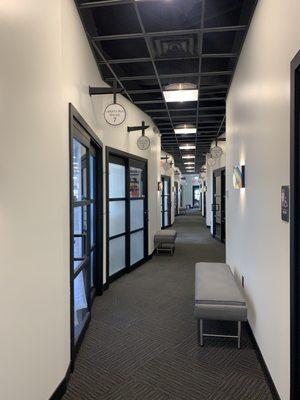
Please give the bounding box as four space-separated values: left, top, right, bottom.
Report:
106 148 148 284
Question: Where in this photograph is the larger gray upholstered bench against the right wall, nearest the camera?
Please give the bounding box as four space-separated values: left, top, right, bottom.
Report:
194 263 247 349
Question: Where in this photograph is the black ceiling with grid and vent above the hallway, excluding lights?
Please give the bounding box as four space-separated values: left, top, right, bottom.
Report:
76 0 257 172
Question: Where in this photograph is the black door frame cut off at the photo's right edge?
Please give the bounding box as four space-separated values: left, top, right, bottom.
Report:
290 48 300 400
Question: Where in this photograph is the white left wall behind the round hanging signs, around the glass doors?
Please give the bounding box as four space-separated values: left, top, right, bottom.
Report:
0 0 160 400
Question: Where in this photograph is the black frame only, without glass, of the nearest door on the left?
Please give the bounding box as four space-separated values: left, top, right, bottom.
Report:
69 103 103 370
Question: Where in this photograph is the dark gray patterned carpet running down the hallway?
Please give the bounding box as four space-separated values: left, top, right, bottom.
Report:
64 214 272 400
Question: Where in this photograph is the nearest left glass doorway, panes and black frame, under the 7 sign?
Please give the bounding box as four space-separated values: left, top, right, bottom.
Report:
69 104 103 367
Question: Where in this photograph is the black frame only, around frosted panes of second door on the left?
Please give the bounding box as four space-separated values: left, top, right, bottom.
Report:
105 146 149 288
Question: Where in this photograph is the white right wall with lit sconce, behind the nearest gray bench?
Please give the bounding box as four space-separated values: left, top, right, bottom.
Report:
226 0 300 400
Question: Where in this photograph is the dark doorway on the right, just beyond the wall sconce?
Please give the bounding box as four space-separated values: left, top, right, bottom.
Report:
212 168 226 243
